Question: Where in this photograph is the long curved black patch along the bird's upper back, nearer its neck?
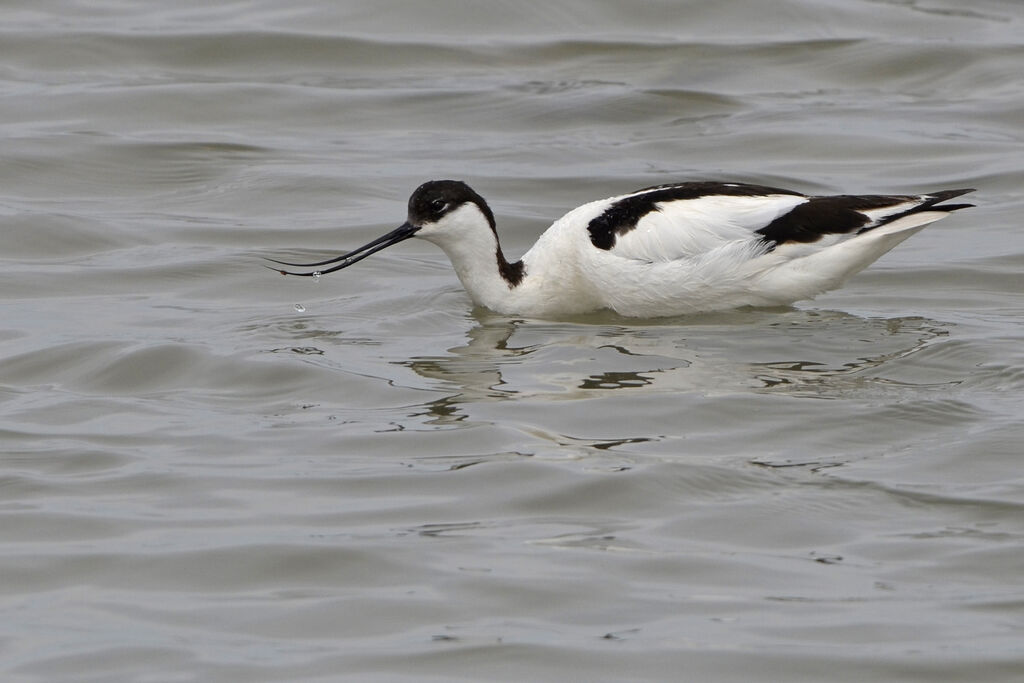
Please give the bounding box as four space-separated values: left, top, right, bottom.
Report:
587 182 804 250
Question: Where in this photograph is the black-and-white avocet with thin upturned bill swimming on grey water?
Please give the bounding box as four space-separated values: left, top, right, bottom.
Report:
267 180 974 318
